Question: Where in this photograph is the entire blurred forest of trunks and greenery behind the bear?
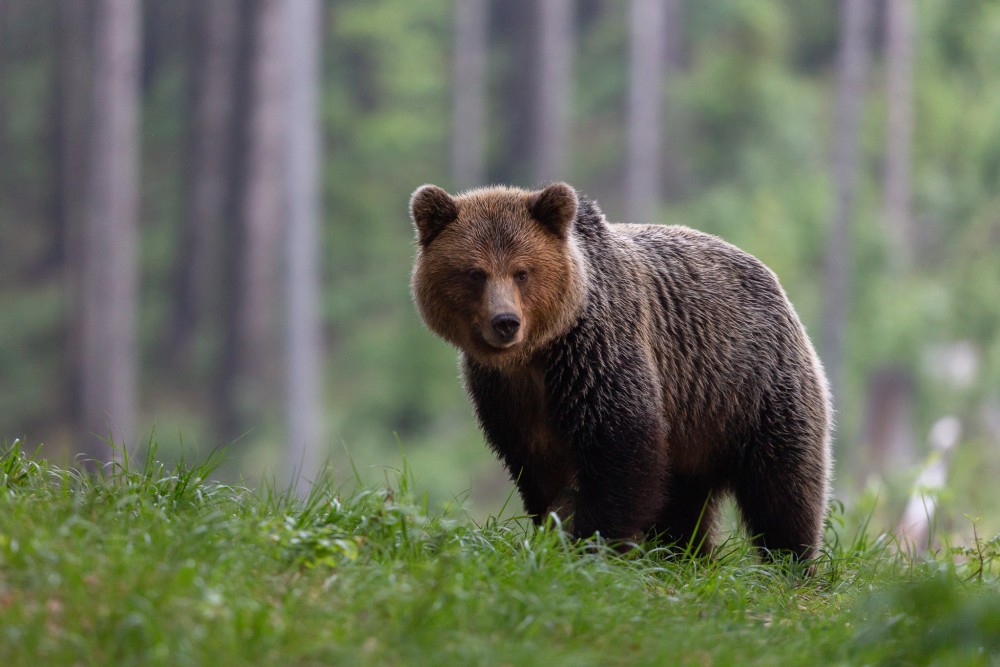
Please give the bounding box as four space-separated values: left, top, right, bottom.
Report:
0 0 1000 534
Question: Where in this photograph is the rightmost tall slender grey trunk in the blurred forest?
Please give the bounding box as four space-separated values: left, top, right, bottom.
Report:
885 0 914 270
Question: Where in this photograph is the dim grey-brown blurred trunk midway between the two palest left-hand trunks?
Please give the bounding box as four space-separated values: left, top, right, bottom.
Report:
167 0 240 360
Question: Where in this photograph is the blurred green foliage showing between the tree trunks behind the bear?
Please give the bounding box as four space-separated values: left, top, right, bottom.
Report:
0 0 1000 529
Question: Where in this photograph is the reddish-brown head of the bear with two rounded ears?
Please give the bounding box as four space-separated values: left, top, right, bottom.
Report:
410 183 585 368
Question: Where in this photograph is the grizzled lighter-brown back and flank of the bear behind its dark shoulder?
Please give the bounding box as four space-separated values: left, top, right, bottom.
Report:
584 224 827 468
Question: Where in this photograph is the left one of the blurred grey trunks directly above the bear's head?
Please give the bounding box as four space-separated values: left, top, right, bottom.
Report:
452 0 487 190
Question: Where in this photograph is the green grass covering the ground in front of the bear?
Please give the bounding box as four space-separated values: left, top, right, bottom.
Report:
0 443 1000 667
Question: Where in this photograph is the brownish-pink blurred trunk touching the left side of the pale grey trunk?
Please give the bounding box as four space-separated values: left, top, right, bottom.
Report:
217 0 287 438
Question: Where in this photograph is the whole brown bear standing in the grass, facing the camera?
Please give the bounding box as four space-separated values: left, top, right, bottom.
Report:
410 183 831 558
